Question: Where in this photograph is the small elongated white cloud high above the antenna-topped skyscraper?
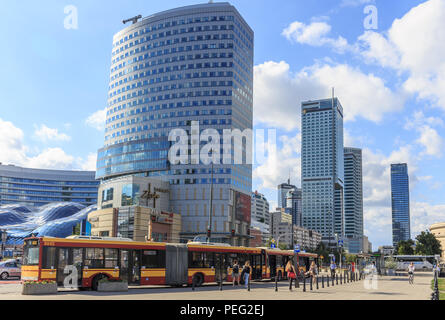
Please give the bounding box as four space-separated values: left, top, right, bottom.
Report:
282 21 350 52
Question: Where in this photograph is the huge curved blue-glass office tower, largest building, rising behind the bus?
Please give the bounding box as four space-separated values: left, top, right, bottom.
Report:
97 3 254 244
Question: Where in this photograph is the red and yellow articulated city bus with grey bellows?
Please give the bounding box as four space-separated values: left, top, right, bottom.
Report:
22 236 317 290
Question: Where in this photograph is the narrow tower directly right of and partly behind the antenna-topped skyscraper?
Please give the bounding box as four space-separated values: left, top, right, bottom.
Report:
344 148 363 253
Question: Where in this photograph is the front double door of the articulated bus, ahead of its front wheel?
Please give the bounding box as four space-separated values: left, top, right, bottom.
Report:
56 248 83 287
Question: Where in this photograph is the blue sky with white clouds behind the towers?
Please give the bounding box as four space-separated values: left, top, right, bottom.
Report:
0 0 445 249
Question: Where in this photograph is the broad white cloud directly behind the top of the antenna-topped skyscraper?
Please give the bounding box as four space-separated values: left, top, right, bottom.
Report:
254 61 404 130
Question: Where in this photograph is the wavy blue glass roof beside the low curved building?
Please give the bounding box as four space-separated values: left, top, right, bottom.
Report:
0 202 97 245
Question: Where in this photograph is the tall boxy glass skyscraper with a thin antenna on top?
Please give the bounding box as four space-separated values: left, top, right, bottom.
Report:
301 98 344 240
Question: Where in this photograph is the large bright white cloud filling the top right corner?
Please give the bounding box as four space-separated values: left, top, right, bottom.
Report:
358 0 445 109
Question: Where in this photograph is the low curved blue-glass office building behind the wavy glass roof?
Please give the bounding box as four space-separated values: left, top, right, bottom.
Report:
0 163 99 207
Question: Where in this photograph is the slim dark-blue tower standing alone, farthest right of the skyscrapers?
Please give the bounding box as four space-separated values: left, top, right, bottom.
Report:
391 163 411 246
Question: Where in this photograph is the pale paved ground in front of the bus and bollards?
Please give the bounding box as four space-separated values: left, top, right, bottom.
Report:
0 272 432 300
